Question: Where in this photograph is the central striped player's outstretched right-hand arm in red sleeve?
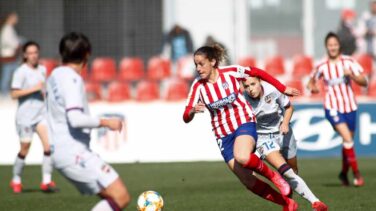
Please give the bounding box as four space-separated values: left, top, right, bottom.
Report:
244 67 300 96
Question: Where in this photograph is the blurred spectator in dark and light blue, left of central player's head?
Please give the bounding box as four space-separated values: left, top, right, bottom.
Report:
162 25 193 63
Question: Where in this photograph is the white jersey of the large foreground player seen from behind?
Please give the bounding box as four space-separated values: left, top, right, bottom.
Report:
46 66 91 168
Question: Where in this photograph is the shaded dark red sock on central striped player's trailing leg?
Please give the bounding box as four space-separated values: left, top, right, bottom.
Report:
248 179 286 206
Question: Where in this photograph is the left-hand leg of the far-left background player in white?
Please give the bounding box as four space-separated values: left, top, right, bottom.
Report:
10 125 33 193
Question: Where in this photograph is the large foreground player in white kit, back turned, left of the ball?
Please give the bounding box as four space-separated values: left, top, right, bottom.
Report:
47 32 130 211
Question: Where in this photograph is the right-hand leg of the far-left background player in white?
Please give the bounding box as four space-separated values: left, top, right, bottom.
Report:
35 121 57 192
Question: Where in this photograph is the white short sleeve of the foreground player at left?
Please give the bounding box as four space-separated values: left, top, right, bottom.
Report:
60 75 84 111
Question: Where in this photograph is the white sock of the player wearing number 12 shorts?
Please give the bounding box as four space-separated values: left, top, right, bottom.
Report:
283 168 319 204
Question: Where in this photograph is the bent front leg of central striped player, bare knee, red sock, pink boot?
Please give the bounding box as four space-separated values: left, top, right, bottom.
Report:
234 135 291 196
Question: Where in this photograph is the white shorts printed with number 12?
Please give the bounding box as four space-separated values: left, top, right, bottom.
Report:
256 128 297 159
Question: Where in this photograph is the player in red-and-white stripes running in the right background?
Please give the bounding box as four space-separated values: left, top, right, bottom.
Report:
308 32 368 186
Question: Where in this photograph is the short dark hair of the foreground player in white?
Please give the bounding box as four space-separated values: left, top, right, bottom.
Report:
59 32 91 63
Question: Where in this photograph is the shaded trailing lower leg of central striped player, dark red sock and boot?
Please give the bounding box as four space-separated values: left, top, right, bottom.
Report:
227 159 298 210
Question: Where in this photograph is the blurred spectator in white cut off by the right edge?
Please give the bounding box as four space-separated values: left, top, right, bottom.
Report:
358 0 376 59
